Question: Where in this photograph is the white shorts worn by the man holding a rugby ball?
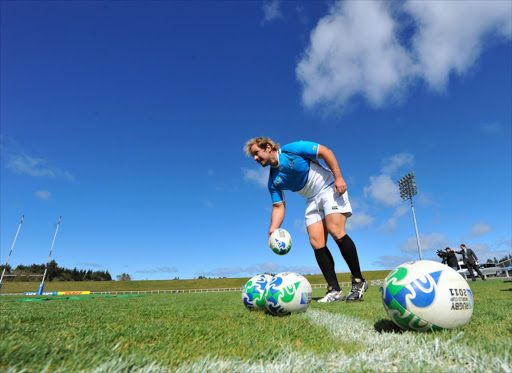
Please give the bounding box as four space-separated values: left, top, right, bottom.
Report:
306 185 352 226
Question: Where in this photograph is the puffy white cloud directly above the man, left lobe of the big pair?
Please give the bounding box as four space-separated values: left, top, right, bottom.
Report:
296 1 411 107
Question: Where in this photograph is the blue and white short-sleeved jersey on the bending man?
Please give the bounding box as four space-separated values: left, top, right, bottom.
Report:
268 141 334 203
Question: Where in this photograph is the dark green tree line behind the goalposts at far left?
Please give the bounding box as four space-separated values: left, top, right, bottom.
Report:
0 260 112 281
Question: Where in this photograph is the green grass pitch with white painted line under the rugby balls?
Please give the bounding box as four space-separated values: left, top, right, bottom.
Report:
0 276 512 372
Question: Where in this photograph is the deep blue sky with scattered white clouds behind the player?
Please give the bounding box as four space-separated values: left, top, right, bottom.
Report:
0 1 512 280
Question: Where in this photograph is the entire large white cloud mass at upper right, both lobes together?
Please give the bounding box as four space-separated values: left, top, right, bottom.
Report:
296 0 512 110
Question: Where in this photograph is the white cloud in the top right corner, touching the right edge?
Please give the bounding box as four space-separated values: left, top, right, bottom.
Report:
404 0 512 89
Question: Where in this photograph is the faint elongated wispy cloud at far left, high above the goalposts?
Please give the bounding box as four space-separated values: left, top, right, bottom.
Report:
7 154 74 181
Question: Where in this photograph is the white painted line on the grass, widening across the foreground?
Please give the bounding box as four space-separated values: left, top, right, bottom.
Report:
90 310 512 373
